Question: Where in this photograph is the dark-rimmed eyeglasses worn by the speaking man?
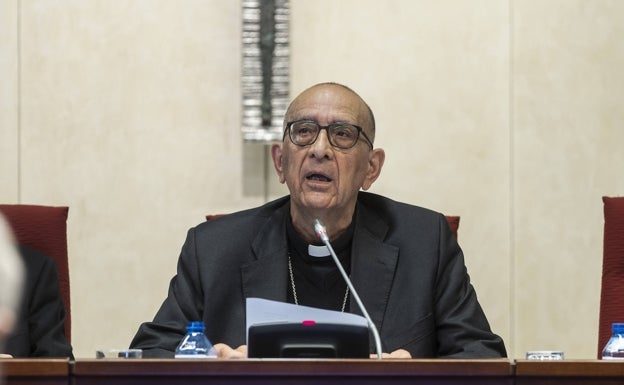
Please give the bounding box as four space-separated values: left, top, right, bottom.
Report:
282 119 373 150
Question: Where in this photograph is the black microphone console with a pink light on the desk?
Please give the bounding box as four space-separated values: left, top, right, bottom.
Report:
247 321 370 358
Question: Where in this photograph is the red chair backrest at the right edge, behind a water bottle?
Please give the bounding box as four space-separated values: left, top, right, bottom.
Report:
598 197 624 358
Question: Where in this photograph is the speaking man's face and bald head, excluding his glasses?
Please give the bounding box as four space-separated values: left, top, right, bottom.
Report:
273 85 383 216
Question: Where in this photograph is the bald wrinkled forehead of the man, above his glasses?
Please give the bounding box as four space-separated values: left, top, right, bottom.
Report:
285 85 370 128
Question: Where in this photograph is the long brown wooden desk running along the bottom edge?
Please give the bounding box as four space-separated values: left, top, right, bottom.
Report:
0 359 624 385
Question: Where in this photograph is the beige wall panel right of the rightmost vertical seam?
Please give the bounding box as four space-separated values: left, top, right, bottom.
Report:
513 0 624 358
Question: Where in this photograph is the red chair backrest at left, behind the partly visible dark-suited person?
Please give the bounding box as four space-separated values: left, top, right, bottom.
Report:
0 204 71 342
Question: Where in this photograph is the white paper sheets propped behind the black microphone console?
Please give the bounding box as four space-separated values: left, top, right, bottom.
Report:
246 298 368 344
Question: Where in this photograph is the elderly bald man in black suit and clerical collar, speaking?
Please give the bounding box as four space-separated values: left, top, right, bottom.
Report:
131 83 506 358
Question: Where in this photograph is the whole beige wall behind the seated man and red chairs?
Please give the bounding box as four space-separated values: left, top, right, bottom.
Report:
0 0 624 358
